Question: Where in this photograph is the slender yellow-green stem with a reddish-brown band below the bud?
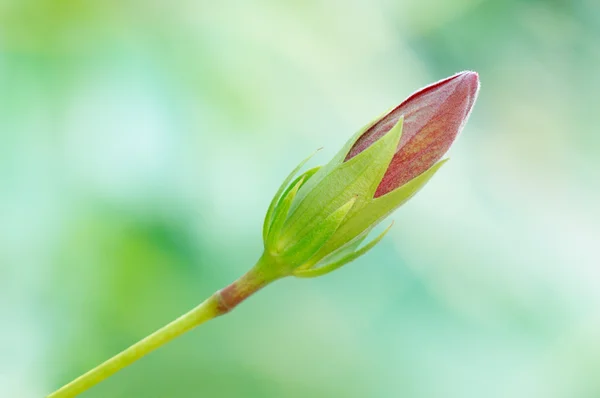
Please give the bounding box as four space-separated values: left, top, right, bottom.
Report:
47 255 284 398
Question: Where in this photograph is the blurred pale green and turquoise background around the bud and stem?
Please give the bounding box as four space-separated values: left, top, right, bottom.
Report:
0 0 600 398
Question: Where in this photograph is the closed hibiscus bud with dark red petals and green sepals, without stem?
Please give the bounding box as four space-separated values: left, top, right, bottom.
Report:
263 72 479 277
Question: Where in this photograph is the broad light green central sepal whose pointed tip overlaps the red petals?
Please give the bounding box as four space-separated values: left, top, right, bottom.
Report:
282 118 403 247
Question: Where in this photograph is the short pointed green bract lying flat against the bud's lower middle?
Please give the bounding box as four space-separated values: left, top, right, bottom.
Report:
282 197 356 265
